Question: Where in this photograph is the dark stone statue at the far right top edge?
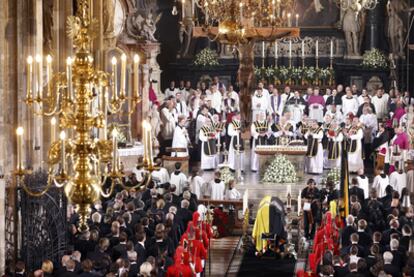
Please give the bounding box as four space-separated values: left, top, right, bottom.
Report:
386 0 407 57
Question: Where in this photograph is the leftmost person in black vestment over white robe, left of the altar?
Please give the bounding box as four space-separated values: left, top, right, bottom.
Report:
200 121 217 170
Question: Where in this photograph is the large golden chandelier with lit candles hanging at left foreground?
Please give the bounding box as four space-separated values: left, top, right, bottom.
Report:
16 0 153 230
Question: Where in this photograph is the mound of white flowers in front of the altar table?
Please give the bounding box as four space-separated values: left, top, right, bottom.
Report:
262 155 298 183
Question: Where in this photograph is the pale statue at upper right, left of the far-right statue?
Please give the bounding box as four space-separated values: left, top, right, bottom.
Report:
342 0 361 57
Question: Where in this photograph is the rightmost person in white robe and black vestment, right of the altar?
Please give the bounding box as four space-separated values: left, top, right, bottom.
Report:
344 117 364 172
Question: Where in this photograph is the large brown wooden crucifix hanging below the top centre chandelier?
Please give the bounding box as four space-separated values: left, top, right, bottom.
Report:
193 27 300 125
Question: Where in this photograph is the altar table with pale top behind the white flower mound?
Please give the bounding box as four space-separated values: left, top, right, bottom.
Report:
255 145 307 181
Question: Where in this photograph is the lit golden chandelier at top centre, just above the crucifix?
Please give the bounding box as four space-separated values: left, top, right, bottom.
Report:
193 0 298 40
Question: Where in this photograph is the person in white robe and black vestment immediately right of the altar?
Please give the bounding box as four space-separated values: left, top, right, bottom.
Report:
305 121 323 174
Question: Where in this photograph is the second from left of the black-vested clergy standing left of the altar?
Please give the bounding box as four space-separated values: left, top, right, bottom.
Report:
227 113 244 170
